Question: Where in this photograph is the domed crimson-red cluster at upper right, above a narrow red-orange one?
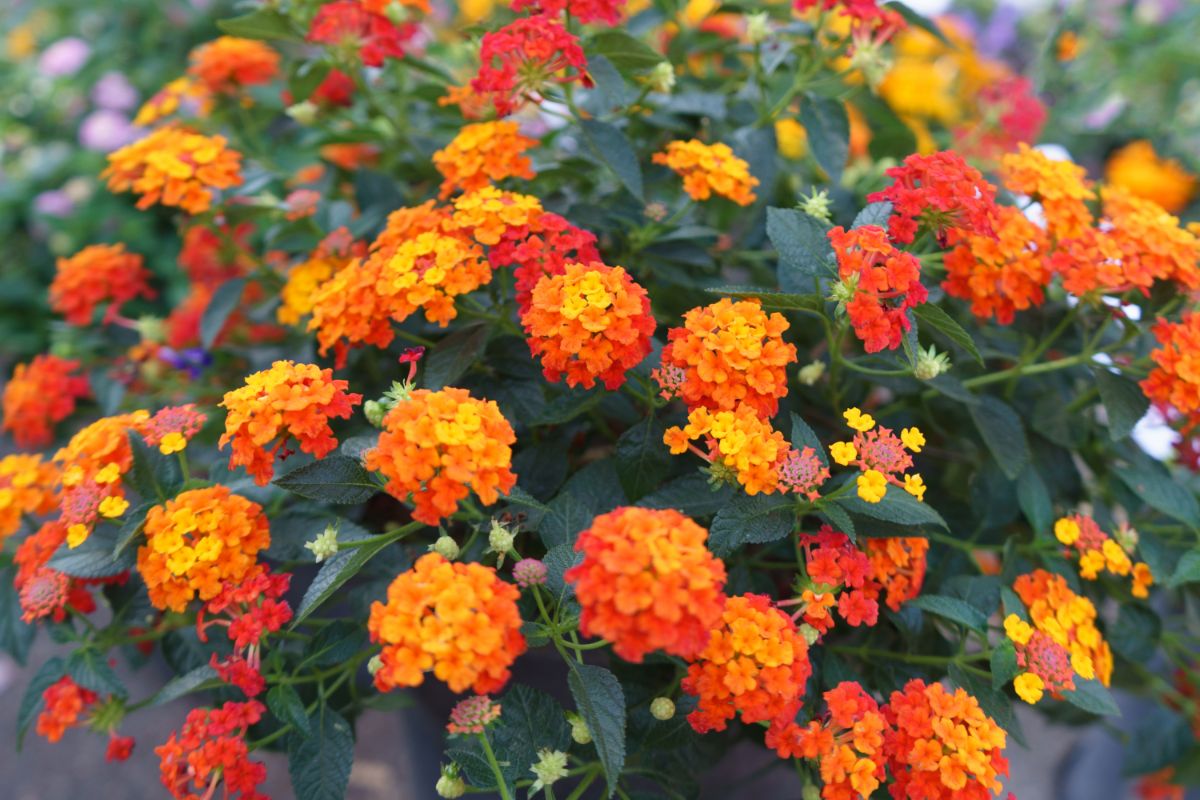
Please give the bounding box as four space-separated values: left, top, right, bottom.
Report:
866 150 996 246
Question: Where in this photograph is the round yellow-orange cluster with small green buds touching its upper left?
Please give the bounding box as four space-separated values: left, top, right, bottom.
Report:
365 389 517 525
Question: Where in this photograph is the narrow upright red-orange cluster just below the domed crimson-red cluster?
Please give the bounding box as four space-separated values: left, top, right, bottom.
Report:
828 225 929 353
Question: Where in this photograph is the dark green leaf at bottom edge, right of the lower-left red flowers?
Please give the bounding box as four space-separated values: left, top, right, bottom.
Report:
288 705 354 800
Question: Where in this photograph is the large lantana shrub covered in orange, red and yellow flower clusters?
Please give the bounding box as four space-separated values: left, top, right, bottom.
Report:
7 0 1200 800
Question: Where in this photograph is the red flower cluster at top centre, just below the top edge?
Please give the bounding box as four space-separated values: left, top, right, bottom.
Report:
470 14 587 116
